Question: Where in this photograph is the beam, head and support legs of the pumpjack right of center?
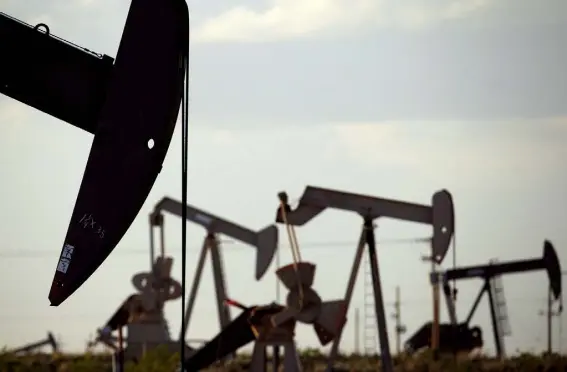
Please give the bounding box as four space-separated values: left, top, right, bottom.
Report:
276 186 455 372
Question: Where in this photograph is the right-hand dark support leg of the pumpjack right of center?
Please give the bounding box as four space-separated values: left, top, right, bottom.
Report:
364 219 394 372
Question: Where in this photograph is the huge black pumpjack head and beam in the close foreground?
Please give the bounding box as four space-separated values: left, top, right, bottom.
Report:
0 0 189 306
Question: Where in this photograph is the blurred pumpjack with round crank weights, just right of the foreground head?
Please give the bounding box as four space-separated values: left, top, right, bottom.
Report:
86 197 278 365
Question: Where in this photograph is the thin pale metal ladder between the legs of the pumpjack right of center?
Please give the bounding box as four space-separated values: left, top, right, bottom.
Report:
362 252 378 355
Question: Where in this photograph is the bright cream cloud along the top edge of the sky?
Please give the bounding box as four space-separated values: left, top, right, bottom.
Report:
195 0 490 42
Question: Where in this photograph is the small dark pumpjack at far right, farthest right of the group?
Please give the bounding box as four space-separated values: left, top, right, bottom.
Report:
405 240 562 358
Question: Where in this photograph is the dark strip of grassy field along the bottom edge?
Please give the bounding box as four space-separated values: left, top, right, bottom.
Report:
0 350 567 372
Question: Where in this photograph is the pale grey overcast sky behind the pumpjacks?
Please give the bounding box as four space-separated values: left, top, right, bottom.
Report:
0 0 567 352
